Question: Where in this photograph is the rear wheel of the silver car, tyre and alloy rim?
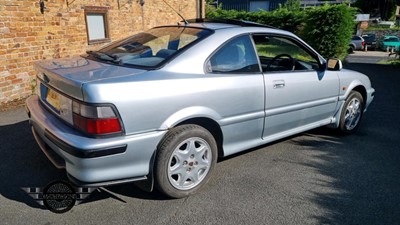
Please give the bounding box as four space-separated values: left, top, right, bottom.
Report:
154 125 217 198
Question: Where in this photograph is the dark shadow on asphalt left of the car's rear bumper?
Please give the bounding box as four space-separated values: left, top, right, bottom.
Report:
0 121 62 208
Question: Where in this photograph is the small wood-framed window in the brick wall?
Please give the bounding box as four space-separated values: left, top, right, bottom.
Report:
85 6 110 44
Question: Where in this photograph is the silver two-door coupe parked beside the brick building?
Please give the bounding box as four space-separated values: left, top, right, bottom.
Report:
26 20 374 198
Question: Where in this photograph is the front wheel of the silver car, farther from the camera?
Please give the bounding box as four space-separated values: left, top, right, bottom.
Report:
339 91 364 134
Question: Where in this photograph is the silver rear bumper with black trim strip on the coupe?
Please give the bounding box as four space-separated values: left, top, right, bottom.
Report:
26 96 166 184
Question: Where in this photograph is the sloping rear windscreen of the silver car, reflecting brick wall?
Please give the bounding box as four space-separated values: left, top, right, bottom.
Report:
88 26 212 68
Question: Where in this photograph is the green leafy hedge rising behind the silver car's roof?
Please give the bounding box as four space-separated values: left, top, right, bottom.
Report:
206 4 356 59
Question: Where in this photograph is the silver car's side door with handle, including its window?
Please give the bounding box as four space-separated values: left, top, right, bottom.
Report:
253 34 339 139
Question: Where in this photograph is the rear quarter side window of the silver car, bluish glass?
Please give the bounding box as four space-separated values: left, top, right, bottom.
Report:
206 36 260 73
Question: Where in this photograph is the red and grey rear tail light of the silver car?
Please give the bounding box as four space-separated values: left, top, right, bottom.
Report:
72 101 122 135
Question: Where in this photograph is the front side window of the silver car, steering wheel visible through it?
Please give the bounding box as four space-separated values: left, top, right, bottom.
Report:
253 35 319 72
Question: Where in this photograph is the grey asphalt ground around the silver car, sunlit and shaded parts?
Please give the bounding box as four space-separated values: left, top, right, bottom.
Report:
0 53 400 225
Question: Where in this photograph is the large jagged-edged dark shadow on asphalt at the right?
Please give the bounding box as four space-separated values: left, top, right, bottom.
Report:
290 64 400 224
